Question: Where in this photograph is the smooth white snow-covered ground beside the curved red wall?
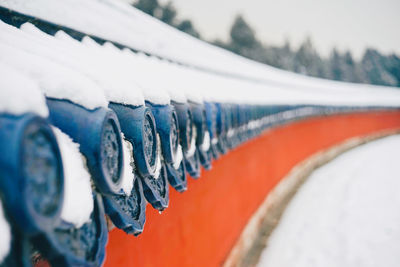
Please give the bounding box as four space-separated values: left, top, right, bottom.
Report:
258 135 400 267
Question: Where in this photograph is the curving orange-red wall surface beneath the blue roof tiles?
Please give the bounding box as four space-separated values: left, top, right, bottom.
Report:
105 111 400 267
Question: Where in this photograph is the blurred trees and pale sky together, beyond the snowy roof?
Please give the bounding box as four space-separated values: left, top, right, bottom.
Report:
126 0 400 87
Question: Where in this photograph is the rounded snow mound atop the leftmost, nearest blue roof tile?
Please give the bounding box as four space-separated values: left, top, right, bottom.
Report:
0 63 49 117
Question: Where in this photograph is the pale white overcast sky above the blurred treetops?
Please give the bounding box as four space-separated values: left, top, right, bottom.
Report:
160 0 400 56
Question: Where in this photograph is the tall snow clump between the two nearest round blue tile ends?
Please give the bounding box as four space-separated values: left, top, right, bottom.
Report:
53 127 93 228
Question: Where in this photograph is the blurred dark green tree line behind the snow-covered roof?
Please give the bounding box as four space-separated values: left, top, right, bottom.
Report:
133 0 400 87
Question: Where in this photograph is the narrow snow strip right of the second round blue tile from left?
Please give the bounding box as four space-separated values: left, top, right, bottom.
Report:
121 137 135 196
